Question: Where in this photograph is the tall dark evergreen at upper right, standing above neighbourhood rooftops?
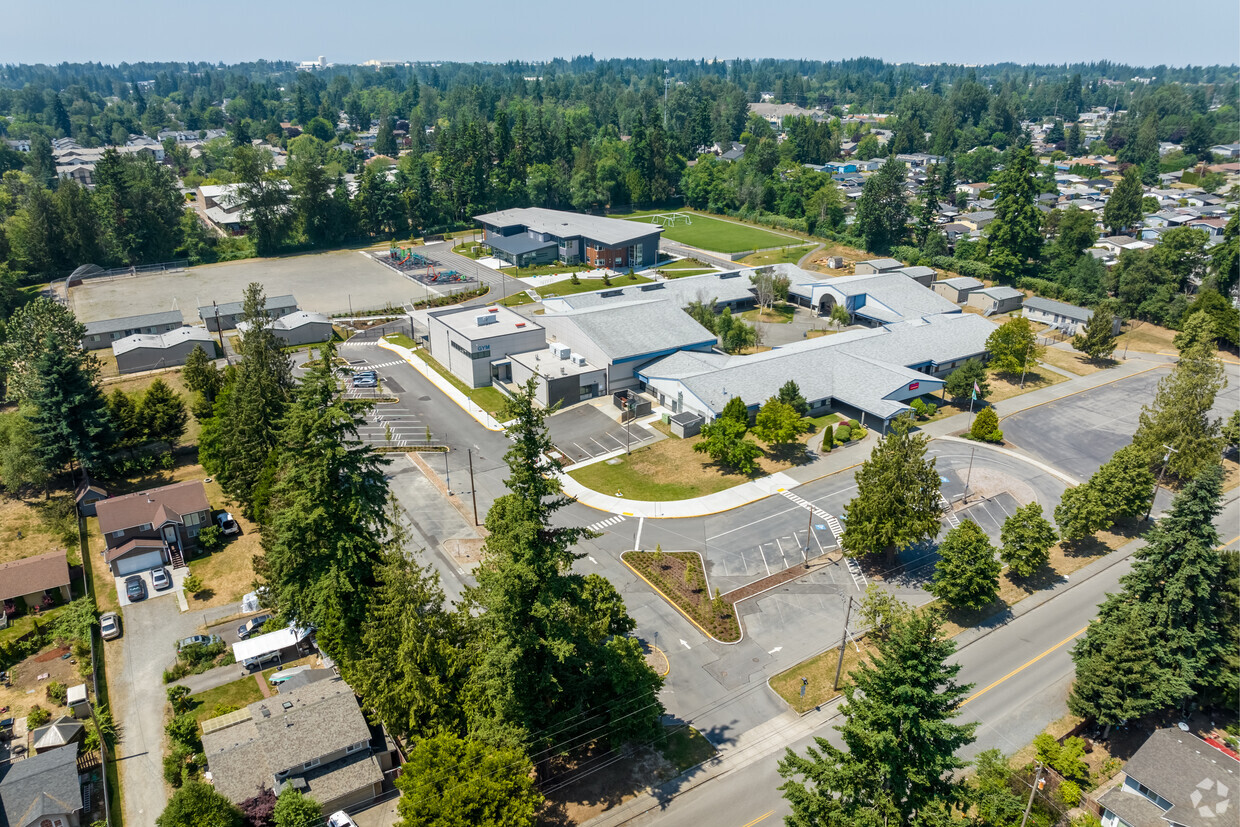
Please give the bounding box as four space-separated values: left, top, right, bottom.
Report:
987 140 1042 284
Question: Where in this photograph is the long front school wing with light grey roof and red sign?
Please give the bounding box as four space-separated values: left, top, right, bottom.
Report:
639 314 994 429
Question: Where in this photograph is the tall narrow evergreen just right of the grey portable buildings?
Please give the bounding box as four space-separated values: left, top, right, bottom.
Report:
216 283 293 518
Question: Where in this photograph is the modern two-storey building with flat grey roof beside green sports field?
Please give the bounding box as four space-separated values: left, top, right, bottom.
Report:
474 207 663 270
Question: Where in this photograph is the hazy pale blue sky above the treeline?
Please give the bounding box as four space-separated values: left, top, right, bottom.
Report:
0 0 1240 66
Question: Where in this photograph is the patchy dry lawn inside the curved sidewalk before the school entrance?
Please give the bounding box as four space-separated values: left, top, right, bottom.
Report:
569 426 800 502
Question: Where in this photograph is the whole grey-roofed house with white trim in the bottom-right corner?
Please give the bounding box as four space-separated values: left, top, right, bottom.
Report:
1099 728 1240 827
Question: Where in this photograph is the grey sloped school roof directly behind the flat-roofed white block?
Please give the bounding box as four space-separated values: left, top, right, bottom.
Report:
542 299 717 362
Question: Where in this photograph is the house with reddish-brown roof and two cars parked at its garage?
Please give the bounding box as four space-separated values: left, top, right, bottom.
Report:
94 480 211 577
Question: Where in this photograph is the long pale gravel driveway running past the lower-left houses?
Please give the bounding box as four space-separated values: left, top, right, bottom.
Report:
104 590 202 825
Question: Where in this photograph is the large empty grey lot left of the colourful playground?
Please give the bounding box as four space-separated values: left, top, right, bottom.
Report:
69 250 424 324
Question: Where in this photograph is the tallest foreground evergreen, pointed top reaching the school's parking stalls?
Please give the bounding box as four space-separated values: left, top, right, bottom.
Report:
467 381 662 758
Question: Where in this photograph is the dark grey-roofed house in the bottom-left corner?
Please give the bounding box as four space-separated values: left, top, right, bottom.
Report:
0 745 83 827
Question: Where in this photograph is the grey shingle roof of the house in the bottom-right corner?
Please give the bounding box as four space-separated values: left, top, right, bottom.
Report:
1123 728 1240 827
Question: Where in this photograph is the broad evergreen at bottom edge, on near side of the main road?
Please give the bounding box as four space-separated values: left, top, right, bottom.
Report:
779 613 976 827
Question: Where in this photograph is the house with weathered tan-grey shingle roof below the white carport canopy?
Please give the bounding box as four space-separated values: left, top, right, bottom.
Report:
202 678 394 813
